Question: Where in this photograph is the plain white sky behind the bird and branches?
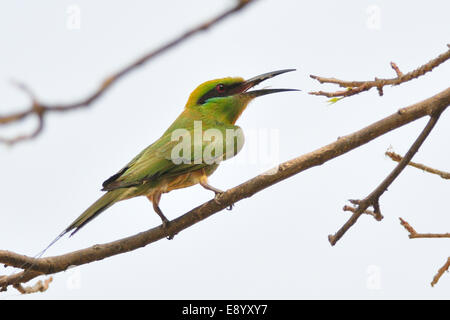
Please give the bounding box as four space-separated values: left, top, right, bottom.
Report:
0 0 450 299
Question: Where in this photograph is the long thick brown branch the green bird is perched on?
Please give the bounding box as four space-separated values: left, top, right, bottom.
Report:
0 88 450 290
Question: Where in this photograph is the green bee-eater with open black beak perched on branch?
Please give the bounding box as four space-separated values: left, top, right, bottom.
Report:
44 69 298 251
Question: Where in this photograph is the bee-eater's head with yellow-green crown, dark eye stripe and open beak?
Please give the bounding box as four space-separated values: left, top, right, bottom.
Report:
186 69 298 124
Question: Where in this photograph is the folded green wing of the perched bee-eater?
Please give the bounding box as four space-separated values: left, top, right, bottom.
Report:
103 120 243 191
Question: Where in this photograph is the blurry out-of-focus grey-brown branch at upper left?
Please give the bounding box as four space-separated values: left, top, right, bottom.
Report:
0 0 257 145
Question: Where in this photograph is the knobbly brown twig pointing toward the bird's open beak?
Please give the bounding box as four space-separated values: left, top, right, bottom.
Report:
309 45 450 98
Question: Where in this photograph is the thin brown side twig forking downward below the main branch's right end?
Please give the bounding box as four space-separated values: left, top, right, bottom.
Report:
328 110 442 246
